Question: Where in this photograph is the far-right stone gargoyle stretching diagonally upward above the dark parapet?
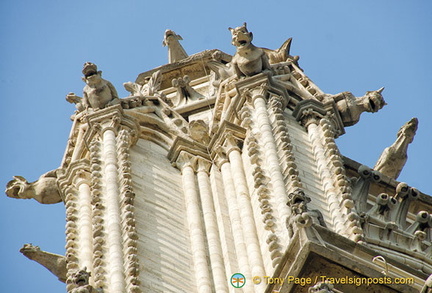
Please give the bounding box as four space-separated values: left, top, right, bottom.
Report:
374 118 418 179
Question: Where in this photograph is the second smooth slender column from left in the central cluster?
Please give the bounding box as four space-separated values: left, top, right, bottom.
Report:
197 157 229 292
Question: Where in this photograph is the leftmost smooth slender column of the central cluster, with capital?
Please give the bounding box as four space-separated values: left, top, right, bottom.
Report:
176 151 212 292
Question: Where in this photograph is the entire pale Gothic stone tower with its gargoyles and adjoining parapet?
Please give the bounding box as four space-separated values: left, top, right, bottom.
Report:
6 24 432 293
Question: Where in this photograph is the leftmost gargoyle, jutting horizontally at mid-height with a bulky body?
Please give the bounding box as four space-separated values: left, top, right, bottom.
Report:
5 170 62 204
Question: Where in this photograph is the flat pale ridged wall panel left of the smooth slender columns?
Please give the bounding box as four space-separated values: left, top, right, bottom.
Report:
131 140 194 292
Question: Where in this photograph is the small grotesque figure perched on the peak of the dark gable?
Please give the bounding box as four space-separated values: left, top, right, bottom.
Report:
286 188 326 237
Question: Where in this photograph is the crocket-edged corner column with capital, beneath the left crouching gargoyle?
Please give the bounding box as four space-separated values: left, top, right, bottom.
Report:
84 106 139 293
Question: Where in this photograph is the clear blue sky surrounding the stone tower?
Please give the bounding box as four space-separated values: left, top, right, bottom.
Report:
0 0 432 293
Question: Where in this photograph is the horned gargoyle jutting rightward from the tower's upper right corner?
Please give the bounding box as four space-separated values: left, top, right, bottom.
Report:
324 88 386 126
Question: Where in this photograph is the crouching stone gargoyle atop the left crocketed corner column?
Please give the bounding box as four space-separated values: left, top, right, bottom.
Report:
66 62 120 112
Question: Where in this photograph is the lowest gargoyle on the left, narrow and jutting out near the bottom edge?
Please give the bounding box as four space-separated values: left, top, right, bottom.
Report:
20 244 67 283
